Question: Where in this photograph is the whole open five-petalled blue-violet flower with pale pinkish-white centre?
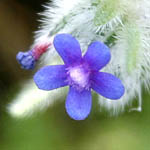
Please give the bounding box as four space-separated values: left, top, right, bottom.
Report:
34 34 125 120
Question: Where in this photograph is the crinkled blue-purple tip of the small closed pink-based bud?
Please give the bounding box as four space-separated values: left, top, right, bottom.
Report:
16 51 36 70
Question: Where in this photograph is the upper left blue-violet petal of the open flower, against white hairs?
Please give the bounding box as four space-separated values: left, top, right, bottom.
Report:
54 34 82 64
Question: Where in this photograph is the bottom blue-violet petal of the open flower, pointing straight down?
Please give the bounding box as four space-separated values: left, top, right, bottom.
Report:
66 87 92 120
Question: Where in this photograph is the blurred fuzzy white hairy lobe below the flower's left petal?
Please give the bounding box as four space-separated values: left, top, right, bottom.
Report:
8 81 66 118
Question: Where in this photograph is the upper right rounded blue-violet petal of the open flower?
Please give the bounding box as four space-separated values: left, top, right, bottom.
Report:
83 42 111 70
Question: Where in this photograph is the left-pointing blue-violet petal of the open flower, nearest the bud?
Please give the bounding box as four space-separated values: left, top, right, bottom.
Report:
34 65 67 90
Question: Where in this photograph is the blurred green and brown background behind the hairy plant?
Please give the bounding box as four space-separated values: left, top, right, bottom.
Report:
0 0 150 150
